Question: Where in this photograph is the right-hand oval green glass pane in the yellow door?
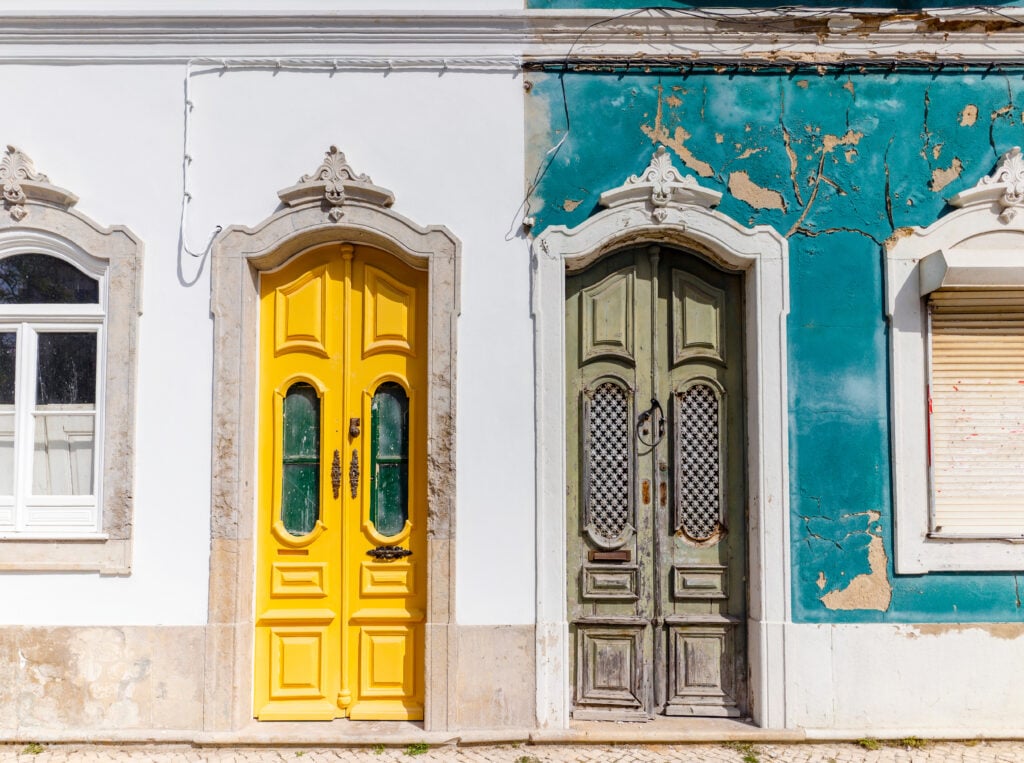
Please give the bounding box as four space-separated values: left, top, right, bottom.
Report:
370 382 409 537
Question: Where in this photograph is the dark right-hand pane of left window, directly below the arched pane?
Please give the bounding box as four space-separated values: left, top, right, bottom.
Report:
36 332 96 409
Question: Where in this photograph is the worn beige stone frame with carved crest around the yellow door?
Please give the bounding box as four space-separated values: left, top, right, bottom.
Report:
204 146 460 731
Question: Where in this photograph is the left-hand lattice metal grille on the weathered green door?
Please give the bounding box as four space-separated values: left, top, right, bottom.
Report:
587 382 630 540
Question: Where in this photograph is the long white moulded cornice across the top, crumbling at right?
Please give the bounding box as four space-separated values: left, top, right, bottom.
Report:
0 8 1024 66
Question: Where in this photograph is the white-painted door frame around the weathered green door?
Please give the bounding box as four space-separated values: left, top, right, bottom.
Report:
532 151 790 728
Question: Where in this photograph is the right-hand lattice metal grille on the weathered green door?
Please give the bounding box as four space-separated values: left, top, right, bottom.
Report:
676 384 721 541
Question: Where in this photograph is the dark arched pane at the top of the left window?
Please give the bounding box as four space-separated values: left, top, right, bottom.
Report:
0 254 99 304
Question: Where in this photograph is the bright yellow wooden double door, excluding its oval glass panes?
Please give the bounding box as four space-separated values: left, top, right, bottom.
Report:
260 244 427 720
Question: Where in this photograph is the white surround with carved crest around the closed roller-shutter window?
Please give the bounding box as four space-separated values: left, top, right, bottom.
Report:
885 149 1024 575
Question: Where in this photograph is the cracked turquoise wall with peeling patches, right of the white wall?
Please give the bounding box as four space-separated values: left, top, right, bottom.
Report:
526 70 1024 622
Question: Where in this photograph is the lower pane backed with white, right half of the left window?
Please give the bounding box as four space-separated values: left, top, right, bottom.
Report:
32 406 95 496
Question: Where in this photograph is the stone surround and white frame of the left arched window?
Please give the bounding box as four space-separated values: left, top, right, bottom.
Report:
0 146 142 575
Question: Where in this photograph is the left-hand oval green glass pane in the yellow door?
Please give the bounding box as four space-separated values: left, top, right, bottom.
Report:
281 383 321 536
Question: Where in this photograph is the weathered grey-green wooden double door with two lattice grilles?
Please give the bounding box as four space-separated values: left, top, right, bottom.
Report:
565 247 746 720
